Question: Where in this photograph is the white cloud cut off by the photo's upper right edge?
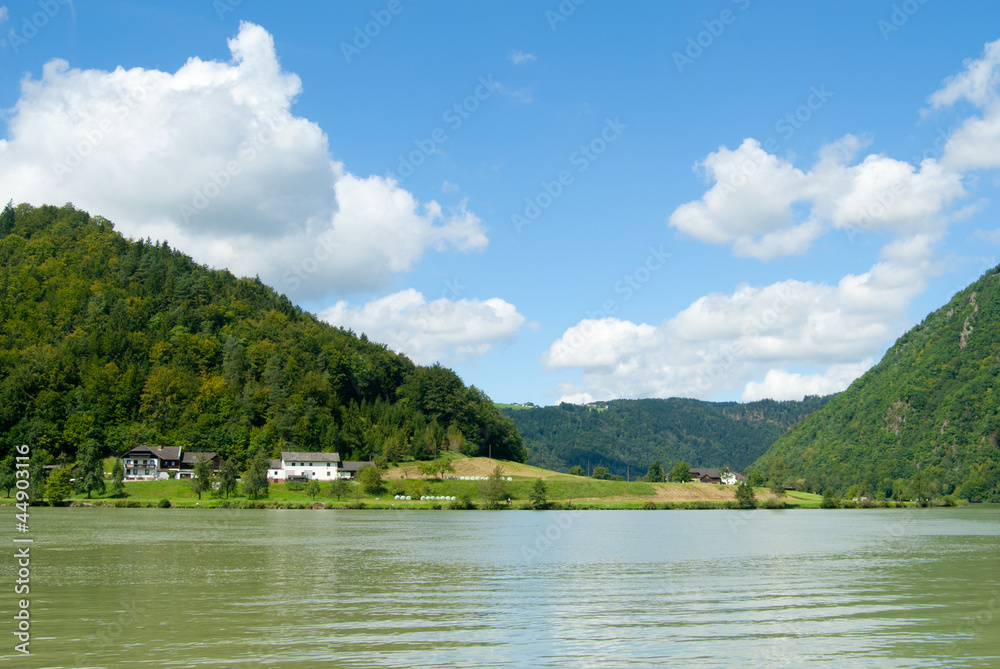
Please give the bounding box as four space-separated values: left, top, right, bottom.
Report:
930 40 1000 170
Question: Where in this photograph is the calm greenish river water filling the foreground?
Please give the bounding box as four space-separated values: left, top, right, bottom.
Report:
0 507 1000 667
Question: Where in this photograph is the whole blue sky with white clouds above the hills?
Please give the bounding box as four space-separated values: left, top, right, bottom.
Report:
0 0 1000 404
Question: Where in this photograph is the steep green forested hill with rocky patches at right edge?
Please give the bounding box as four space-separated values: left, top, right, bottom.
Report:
759 269 1000 502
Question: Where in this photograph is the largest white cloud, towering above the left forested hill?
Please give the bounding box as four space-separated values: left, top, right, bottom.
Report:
0 23 488 298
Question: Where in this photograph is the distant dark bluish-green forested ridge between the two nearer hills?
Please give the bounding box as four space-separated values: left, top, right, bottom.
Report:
503 397 826 476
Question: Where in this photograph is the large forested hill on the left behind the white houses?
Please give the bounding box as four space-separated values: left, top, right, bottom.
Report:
0 205 526 462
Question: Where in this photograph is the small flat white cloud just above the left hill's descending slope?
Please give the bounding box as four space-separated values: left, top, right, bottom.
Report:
320 288 525 364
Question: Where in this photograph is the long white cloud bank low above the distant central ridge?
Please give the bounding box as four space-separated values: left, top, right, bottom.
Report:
542 235 940 401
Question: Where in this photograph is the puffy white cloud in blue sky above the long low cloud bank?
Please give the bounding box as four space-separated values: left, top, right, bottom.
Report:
668 135 966 260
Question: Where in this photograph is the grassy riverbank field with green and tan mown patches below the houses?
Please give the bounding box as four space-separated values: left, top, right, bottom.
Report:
0 453 820 509
